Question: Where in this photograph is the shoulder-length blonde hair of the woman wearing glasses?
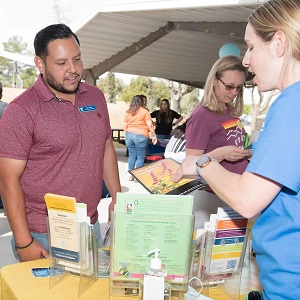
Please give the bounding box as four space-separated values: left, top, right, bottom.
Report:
201 55 247 118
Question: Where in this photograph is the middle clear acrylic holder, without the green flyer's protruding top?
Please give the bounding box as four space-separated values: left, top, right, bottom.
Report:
110 210 194 300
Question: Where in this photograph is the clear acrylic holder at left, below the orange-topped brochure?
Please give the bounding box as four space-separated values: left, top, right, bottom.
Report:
48 218 101 299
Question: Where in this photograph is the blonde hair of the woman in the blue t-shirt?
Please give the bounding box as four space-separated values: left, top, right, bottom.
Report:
248 0 300 76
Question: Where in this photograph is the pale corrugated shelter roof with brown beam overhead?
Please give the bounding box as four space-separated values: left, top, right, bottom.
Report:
73 0 265 88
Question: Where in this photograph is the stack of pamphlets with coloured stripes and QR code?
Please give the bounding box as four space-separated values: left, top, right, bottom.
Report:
194 207 249 285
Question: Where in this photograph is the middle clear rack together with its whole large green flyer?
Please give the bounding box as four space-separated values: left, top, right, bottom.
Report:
110 194 194 300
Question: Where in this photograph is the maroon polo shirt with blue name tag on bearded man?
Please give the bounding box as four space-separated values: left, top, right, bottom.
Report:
0 75 111 232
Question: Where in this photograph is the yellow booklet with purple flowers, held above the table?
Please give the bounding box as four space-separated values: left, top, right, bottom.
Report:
129 158 208 195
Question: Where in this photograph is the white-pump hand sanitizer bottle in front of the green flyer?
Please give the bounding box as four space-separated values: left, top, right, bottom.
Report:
140 249 170 300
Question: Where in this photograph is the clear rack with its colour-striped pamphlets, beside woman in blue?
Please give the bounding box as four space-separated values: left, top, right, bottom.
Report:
193 207 250 300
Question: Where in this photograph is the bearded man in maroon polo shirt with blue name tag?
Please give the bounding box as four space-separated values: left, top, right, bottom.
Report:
0 24 121 261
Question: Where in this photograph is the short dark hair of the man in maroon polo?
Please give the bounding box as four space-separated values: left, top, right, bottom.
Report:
34 24 80 60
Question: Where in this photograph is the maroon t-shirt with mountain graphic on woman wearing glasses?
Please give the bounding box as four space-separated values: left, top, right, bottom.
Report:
186 104 248 174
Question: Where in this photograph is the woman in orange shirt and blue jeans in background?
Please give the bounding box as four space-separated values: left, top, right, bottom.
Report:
124 95 157 181
